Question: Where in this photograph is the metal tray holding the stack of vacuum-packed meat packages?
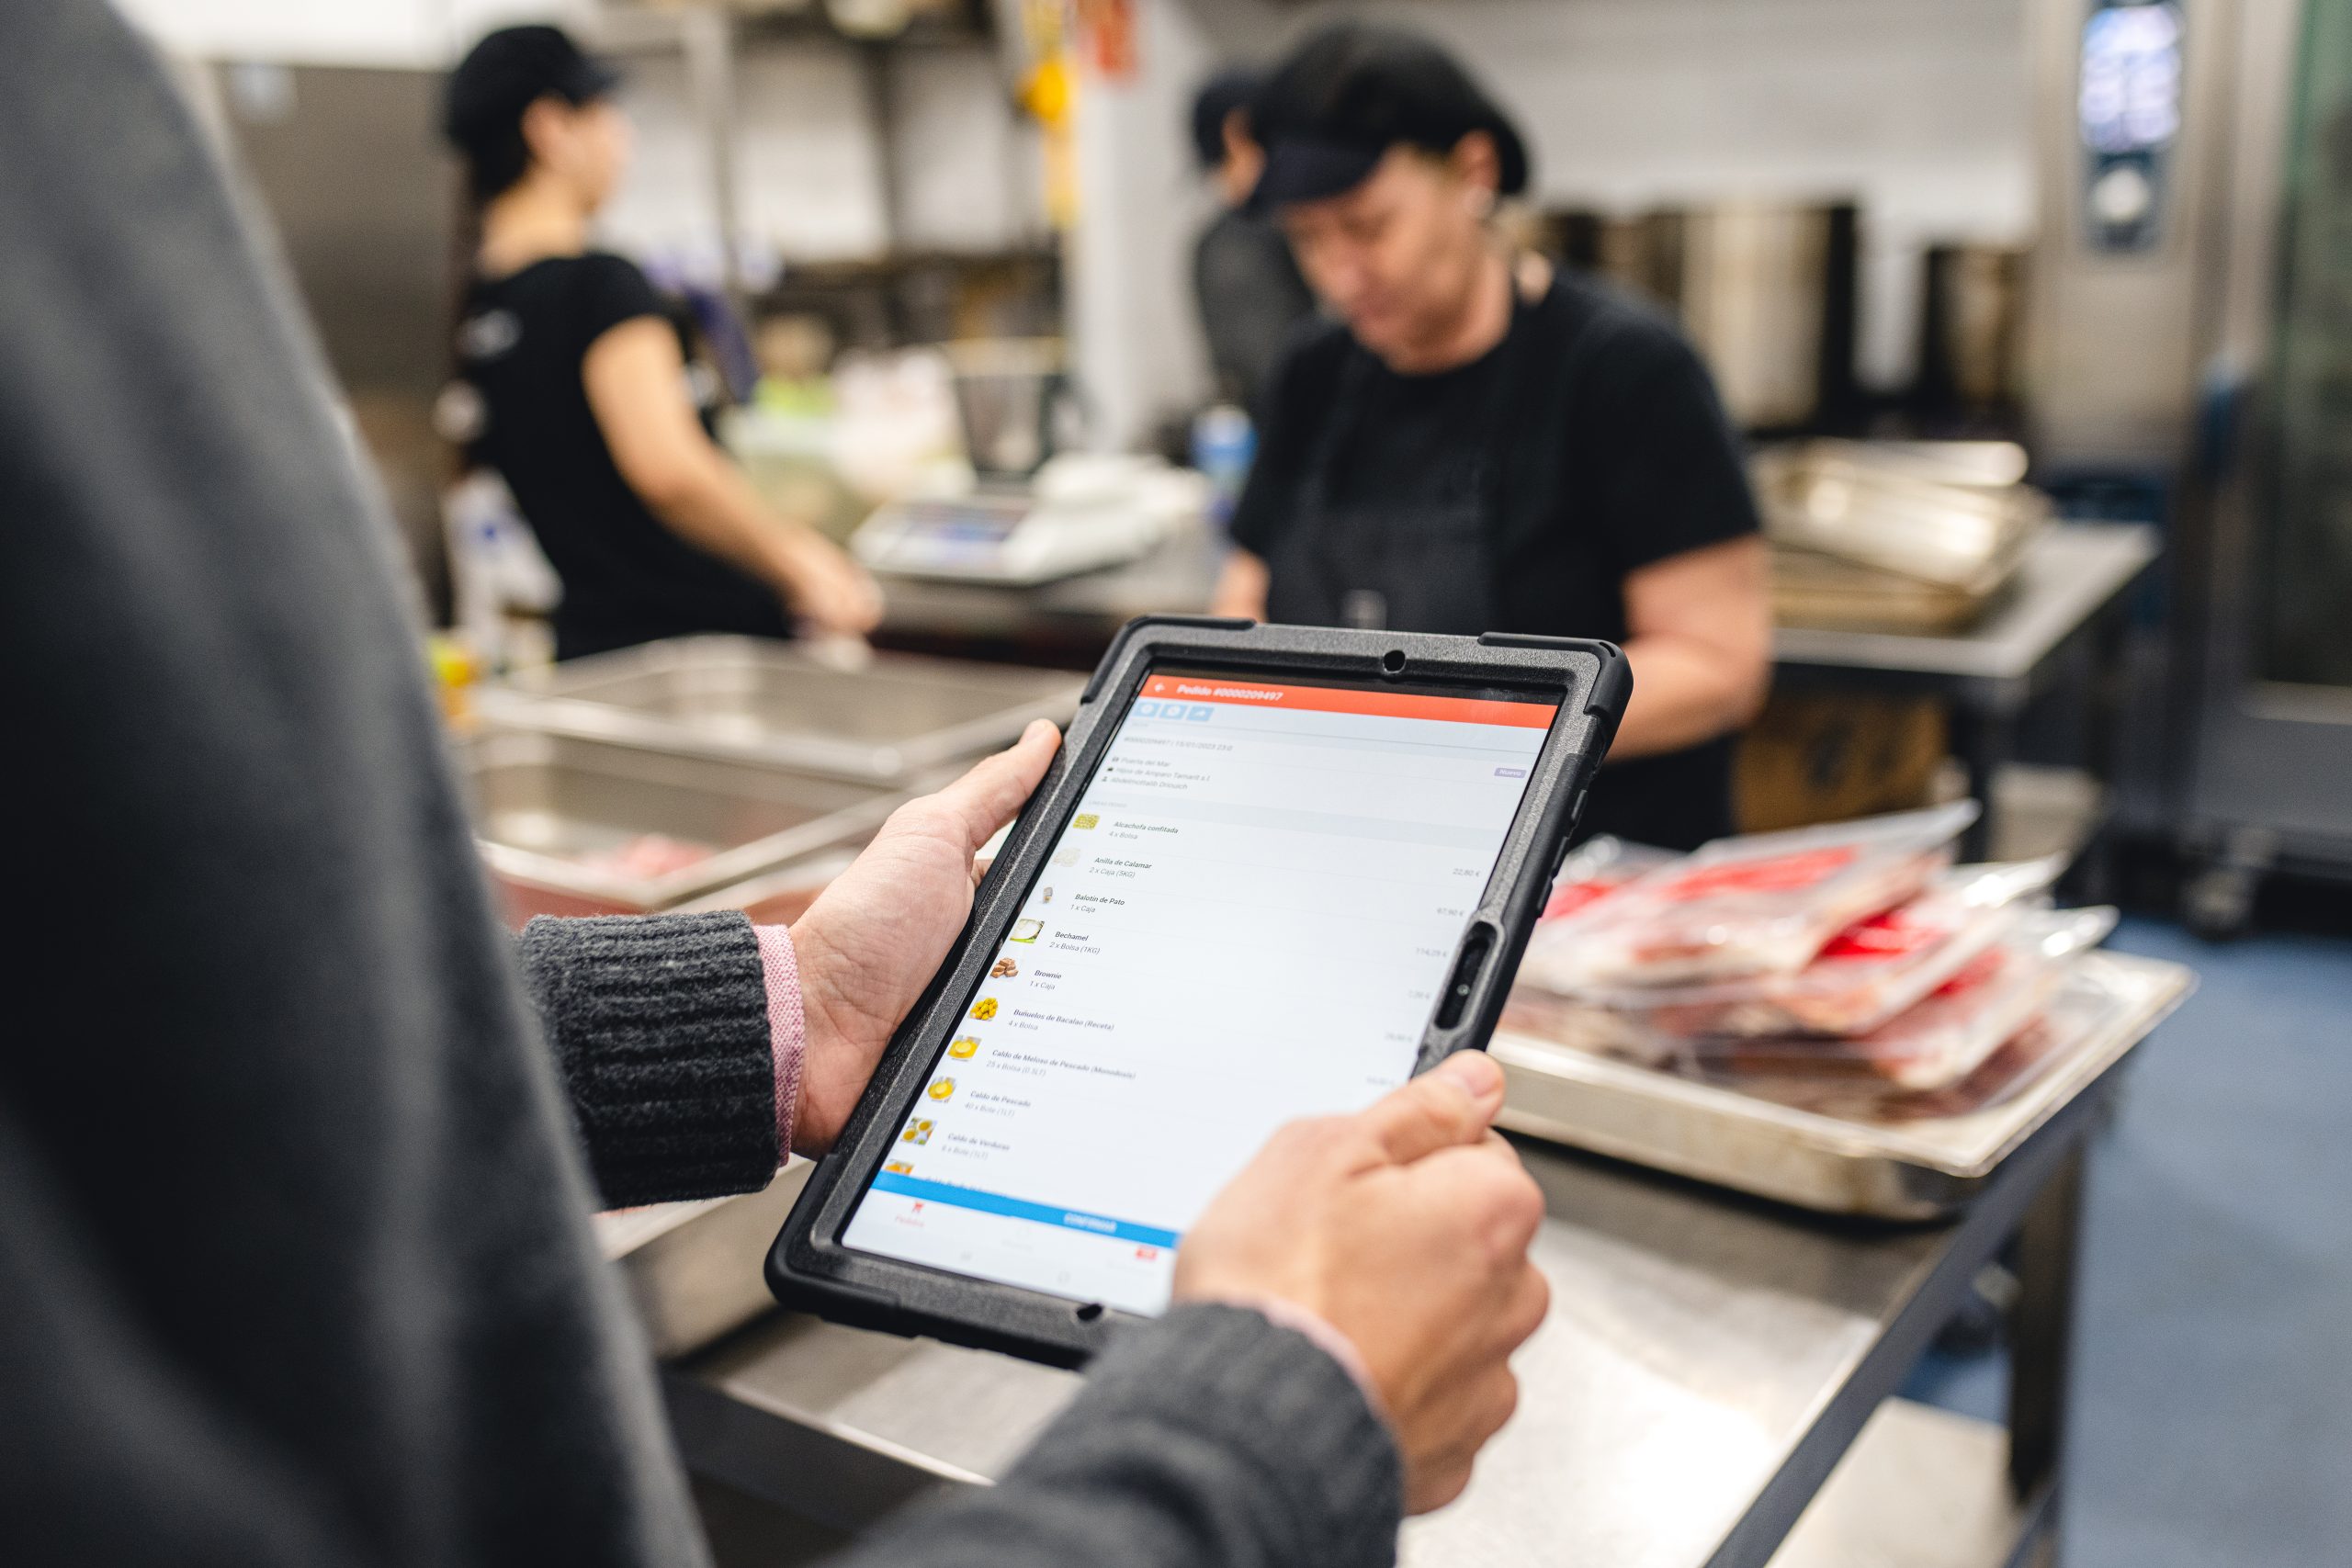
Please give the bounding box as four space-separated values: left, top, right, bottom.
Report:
1488 952 2197 1220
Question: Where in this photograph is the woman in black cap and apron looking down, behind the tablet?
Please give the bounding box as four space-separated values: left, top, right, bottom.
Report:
1216 26 1771 846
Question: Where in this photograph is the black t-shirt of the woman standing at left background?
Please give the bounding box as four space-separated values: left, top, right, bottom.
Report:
457 252 790 659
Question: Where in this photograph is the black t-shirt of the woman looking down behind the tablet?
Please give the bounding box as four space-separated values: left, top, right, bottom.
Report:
1232 277 1757 849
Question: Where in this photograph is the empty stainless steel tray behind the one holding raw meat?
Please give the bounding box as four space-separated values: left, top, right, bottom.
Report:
475 637 1087 783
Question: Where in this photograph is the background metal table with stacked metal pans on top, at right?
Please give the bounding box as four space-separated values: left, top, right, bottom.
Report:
1773 522 2162 861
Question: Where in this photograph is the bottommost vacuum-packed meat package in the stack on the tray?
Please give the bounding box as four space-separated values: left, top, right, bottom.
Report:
1689 909 2114 1090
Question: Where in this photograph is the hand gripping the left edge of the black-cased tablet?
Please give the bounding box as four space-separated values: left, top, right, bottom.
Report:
793 719 1061 1155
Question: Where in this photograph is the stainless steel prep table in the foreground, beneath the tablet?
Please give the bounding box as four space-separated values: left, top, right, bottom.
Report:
665 1053 2114 1568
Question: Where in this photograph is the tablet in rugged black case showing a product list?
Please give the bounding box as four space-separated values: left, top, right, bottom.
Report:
769 618 1633 1366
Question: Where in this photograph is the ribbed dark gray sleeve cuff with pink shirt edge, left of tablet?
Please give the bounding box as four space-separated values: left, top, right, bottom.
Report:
517 912 783 1208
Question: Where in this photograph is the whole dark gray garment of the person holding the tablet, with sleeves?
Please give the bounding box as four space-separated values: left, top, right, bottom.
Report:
0 0 1399 1568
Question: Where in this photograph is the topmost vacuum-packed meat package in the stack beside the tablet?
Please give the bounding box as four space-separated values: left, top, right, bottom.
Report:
1521 802 1975 995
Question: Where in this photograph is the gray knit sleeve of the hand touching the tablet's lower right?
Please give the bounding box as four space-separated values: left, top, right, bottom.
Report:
832 1304 1404 1568
